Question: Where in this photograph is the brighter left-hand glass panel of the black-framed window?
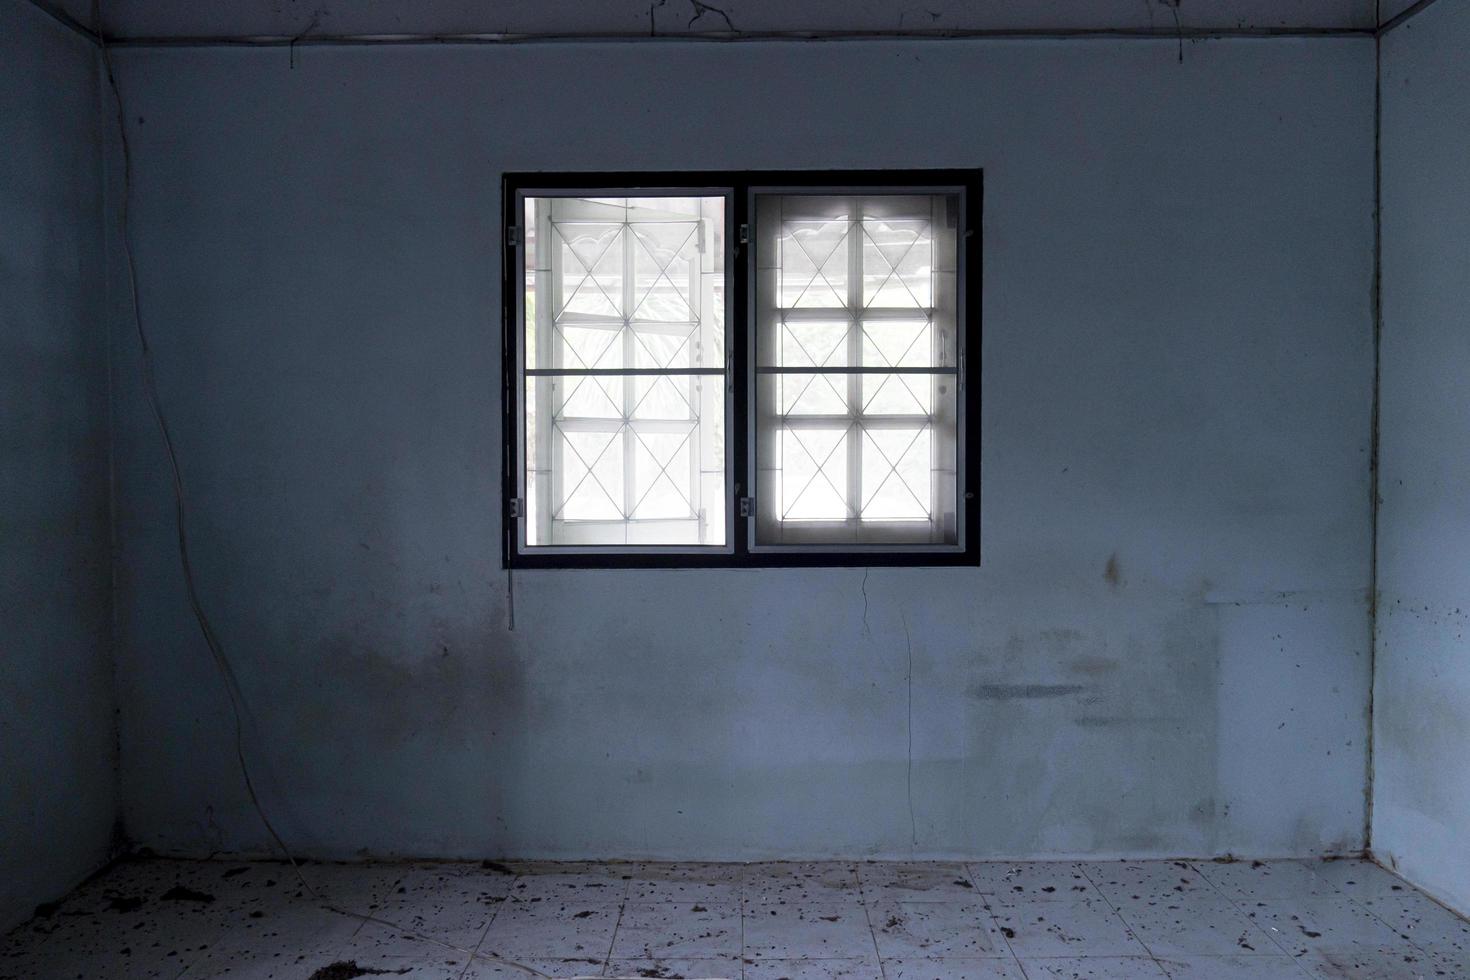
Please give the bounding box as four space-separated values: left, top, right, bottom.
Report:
522 197 729 548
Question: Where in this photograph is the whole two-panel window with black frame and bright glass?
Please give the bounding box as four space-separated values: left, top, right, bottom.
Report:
503 170 980 567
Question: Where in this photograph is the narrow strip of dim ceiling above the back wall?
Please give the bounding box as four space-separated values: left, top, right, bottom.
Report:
60 0 1387 40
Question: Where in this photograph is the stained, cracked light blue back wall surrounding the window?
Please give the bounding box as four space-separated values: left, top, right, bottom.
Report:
106 38 1373 858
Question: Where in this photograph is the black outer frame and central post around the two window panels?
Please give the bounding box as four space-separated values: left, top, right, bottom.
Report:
500 169 983 569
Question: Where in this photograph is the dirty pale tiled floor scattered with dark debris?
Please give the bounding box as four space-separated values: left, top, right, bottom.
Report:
0 860 1470 980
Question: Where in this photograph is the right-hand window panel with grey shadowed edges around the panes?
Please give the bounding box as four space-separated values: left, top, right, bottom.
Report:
753 192 960 547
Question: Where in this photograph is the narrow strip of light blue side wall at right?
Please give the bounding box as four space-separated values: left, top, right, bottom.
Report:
1373 0 1470 911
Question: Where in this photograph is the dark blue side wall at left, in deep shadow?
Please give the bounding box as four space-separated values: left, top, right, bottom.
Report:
0 3 118 929
